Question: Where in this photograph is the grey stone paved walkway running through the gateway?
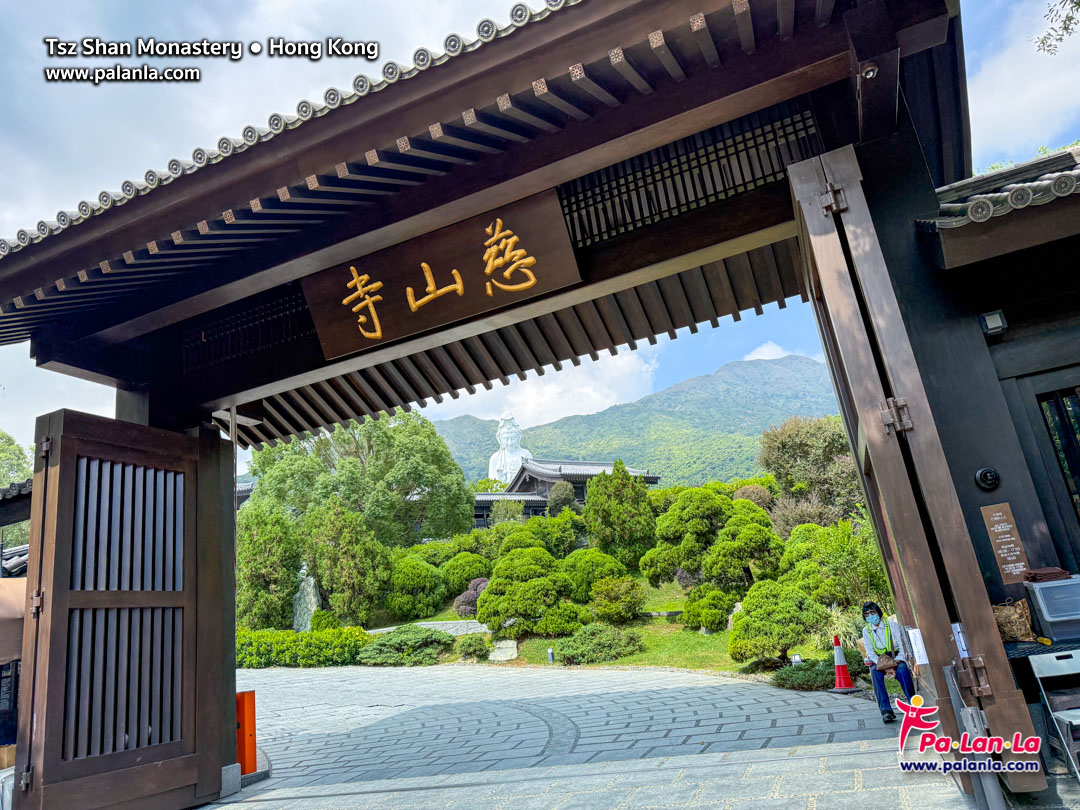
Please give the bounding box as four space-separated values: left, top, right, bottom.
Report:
212 665 973 810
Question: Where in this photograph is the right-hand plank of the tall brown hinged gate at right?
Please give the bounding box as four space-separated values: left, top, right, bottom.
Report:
821 146 1045 791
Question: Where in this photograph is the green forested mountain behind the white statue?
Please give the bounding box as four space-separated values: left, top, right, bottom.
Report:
434 354 838 486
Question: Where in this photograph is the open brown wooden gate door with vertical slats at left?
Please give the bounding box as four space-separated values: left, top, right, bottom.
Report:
15 410 220 809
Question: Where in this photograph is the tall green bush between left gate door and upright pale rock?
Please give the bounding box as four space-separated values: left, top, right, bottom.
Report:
237 497 300 630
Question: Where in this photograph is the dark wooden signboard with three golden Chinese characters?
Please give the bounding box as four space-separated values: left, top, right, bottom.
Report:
302 190 581 360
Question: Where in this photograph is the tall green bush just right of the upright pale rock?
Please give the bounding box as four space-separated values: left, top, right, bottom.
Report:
303 496 392 624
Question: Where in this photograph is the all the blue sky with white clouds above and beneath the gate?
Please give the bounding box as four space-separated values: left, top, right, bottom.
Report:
0 0 1080 457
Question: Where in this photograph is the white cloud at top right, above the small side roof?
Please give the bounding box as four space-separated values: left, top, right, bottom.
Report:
968 0 1080 170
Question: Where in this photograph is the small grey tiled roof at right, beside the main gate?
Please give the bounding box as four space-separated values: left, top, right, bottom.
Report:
918 149 1080 231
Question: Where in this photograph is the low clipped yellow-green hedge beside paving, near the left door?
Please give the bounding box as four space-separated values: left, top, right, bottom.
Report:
237 627 372 670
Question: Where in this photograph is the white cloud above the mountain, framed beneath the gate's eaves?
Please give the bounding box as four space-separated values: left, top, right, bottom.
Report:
424 346 660 428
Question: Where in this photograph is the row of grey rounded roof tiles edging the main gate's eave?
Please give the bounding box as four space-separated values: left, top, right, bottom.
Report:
0 0 581 259
